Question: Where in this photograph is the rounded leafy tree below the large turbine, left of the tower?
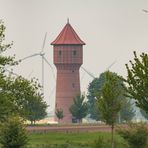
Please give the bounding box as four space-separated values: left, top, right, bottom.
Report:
5 76 48 123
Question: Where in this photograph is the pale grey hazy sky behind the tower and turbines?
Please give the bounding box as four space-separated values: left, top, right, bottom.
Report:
0 0 148 111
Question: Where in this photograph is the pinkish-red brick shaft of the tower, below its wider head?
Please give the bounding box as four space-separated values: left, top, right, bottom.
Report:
56 65 80 123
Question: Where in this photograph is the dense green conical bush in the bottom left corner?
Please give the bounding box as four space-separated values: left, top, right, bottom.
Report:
0 116 28 148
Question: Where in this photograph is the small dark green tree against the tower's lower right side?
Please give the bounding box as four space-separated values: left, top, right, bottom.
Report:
69 94 88 123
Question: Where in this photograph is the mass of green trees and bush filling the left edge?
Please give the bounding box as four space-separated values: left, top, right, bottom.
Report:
0 21 47 148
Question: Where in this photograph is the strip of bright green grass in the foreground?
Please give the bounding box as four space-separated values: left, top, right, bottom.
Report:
29 132 128 148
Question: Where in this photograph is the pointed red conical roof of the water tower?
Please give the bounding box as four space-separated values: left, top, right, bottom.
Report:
51 22 85 45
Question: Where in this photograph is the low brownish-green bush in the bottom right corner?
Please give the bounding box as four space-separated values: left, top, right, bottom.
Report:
117 124 148 148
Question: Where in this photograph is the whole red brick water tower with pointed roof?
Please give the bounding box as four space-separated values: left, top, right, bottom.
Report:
51 21 85 123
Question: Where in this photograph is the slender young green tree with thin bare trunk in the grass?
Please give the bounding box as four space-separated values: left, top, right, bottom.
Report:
96 71 122 148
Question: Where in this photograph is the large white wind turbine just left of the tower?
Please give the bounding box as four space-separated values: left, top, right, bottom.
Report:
19 32 55 95
